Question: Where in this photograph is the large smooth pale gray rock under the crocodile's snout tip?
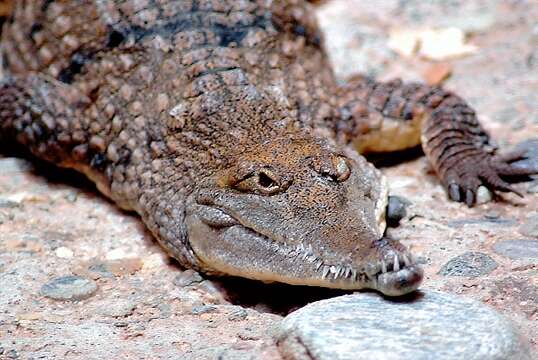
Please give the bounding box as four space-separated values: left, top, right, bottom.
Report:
277 290 531 360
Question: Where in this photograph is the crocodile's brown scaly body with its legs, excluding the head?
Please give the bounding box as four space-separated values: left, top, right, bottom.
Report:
0 0 532 276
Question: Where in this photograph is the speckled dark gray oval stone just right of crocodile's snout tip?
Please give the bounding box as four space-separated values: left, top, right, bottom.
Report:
439 251 497 277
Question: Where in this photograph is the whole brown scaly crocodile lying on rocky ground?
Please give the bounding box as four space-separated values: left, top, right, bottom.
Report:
0 0 537 296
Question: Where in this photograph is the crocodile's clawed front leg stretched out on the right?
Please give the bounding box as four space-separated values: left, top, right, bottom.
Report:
335 77 538 206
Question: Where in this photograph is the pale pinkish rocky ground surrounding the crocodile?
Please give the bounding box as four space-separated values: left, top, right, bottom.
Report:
0 0 538 359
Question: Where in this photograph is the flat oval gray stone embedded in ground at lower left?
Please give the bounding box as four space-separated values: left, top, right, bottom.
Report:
40 275 97 301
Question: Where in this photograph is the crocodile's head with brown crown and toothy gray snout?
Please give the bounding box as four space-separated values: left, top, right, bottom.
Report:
186 137 422 296
